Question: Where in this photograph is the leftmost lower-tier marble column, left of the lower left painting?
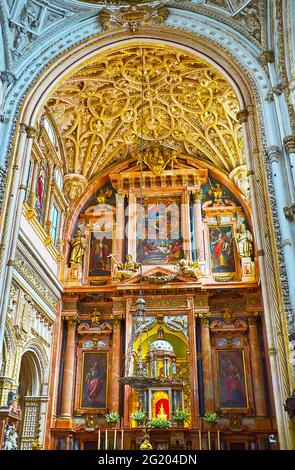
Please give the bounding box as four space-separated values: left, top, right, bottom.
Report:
61 316 77 418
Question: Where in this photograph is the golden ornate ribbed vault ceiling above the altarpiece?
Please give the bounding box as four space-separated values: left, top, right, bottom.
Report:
47 45 244 181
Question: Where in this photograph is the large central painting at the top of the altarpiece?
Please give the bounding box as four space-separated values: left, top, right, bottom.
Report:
136 196 183 265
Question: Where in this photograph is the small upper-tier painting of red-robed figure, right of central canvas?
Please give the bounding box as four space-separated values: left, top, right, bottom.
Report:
209 225 235 273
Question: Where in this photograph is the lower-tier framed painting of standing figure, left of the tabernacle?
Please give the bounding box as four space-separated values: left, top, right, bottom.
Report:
81 352 108 409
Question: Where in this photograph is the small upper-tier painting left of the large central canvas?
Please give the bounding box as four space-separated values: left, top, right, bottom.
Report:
89 231 113 277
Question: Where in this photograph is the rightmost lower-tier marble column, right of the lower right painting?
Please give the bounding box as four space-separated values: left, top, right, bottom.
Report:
248 316 267 416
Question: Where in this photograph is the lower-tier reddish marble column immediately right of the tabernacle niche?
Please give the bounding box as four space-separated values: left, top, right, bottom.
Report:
199 314 215 413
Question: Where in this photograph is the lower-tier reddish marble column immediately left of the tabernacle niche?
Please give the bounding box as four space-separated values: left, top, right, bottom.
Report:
110 317 121 412
